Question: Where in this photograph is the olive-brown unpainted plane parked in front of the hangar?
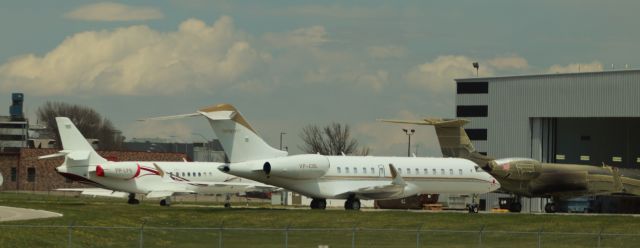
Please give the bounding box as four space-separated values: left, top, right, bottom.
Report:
380 118 640 213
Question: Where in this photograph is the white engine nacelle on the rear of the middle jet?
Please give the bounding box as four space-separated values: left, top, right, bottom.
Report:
262 154 329 179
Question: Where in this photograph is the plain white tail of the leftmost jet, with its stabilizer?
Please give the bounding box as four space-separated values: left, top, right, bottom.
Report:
39 117 107 166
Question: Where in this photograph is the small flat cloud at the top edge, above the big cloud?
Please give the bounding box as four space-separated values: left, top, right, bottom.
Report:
64 2 163 21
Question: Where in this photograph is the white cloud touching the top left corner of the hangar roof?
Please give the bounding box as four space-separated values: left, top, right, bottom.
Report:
405 55 529 92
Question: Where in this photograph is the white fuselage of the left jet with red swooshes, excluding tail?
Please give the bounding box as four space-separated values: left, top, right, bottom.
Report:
56 162 263 194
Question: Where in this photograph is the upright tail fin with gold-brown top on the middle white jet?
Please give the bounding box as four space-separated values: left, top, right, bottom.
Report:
198 104 287 163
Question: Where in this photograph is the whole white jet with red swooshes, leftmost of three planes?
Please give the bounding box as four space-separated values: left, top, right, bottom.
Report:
39 117 276 207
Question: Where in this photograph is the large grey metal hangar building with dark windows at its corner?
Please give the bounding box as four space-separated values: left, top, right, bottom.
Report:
455 70 640 212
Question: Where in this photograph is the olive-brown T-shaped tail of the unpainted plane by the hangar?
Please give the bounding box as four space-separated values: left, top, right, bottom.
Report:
380 118 494 167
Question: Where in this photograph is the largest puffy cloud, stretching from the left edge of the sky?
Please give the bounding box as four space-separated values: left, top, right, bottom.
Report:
0 17 270 95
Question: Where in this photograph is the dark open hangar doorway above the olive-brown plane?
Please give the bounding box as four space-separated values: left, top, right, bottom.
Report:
531 117 640 168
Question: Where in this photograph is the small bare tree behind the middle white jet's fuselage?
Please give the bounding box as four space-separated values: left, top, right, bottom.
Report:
299 122 370 156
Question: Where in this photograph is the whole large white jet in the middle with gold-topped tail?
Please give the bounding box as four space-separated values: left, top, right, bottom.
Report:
145 104 500 212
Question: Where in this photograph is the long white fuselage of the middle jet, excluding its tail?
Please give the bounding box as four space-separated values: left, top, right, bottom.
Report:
227 154 500 199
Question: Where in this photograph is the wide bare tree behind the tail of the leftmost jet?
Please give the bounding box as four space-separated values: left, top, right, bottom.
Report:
37 102 124 150
